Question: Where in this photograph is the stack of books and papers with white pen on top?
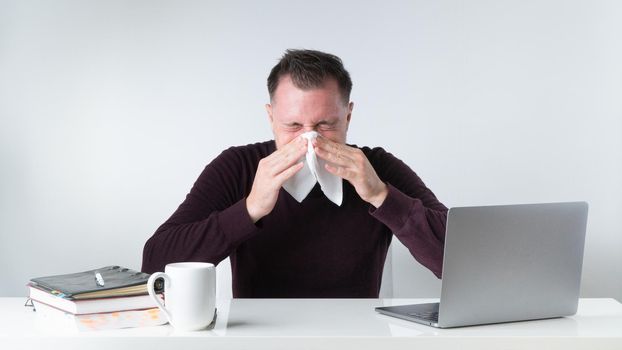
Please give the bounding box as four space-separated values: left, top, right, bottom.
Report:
28 266 168 331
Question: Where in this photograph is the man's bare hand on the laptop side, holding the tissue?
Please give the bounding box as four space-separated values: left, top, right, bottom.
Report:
313 136 389 208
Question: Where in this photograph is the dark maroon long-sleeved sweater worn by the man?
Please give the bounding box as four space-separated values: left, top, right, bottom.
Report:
142 141 447 298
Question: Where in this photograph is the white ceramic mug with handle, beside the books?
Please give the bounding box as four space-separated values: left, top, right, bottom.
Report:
147 262 216 331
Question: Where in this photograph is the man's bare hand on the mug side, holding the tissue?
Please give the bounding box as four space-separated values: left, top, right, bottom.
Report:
246 136 307 222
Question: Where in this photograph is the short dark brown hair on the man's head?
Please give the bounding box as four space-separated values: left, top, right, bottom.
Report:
268 49 352 104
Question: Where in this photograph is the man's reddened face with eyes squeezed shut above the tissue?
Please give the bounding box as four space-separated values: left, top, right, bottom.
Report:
266 75 353 148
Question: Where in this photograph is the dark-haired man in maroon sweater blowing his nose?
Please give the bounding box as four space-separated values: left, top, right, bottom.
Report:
142 50 447 298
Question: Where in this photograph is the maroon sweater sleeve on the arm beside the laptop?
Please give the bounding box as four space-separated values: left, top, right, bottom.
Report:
370 149 448 278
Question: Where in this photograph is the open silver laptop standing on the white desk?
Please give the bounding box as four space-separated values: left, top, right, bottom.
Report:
376 202 588 328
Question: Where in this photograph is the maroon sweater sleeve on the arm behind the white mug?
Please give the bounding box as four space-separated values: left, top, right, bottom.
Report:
142 149 258 273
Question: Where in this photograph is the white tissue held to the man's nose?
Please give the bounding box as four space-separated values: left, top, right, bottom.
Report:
283 131 343 205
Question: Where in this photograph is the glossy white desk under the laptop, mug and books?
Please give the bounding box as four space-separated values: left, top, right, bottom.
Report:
0 298 622 350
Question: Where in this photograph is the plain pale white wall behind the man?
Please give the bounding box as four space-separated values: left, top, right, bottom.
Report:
0 0 622 300
